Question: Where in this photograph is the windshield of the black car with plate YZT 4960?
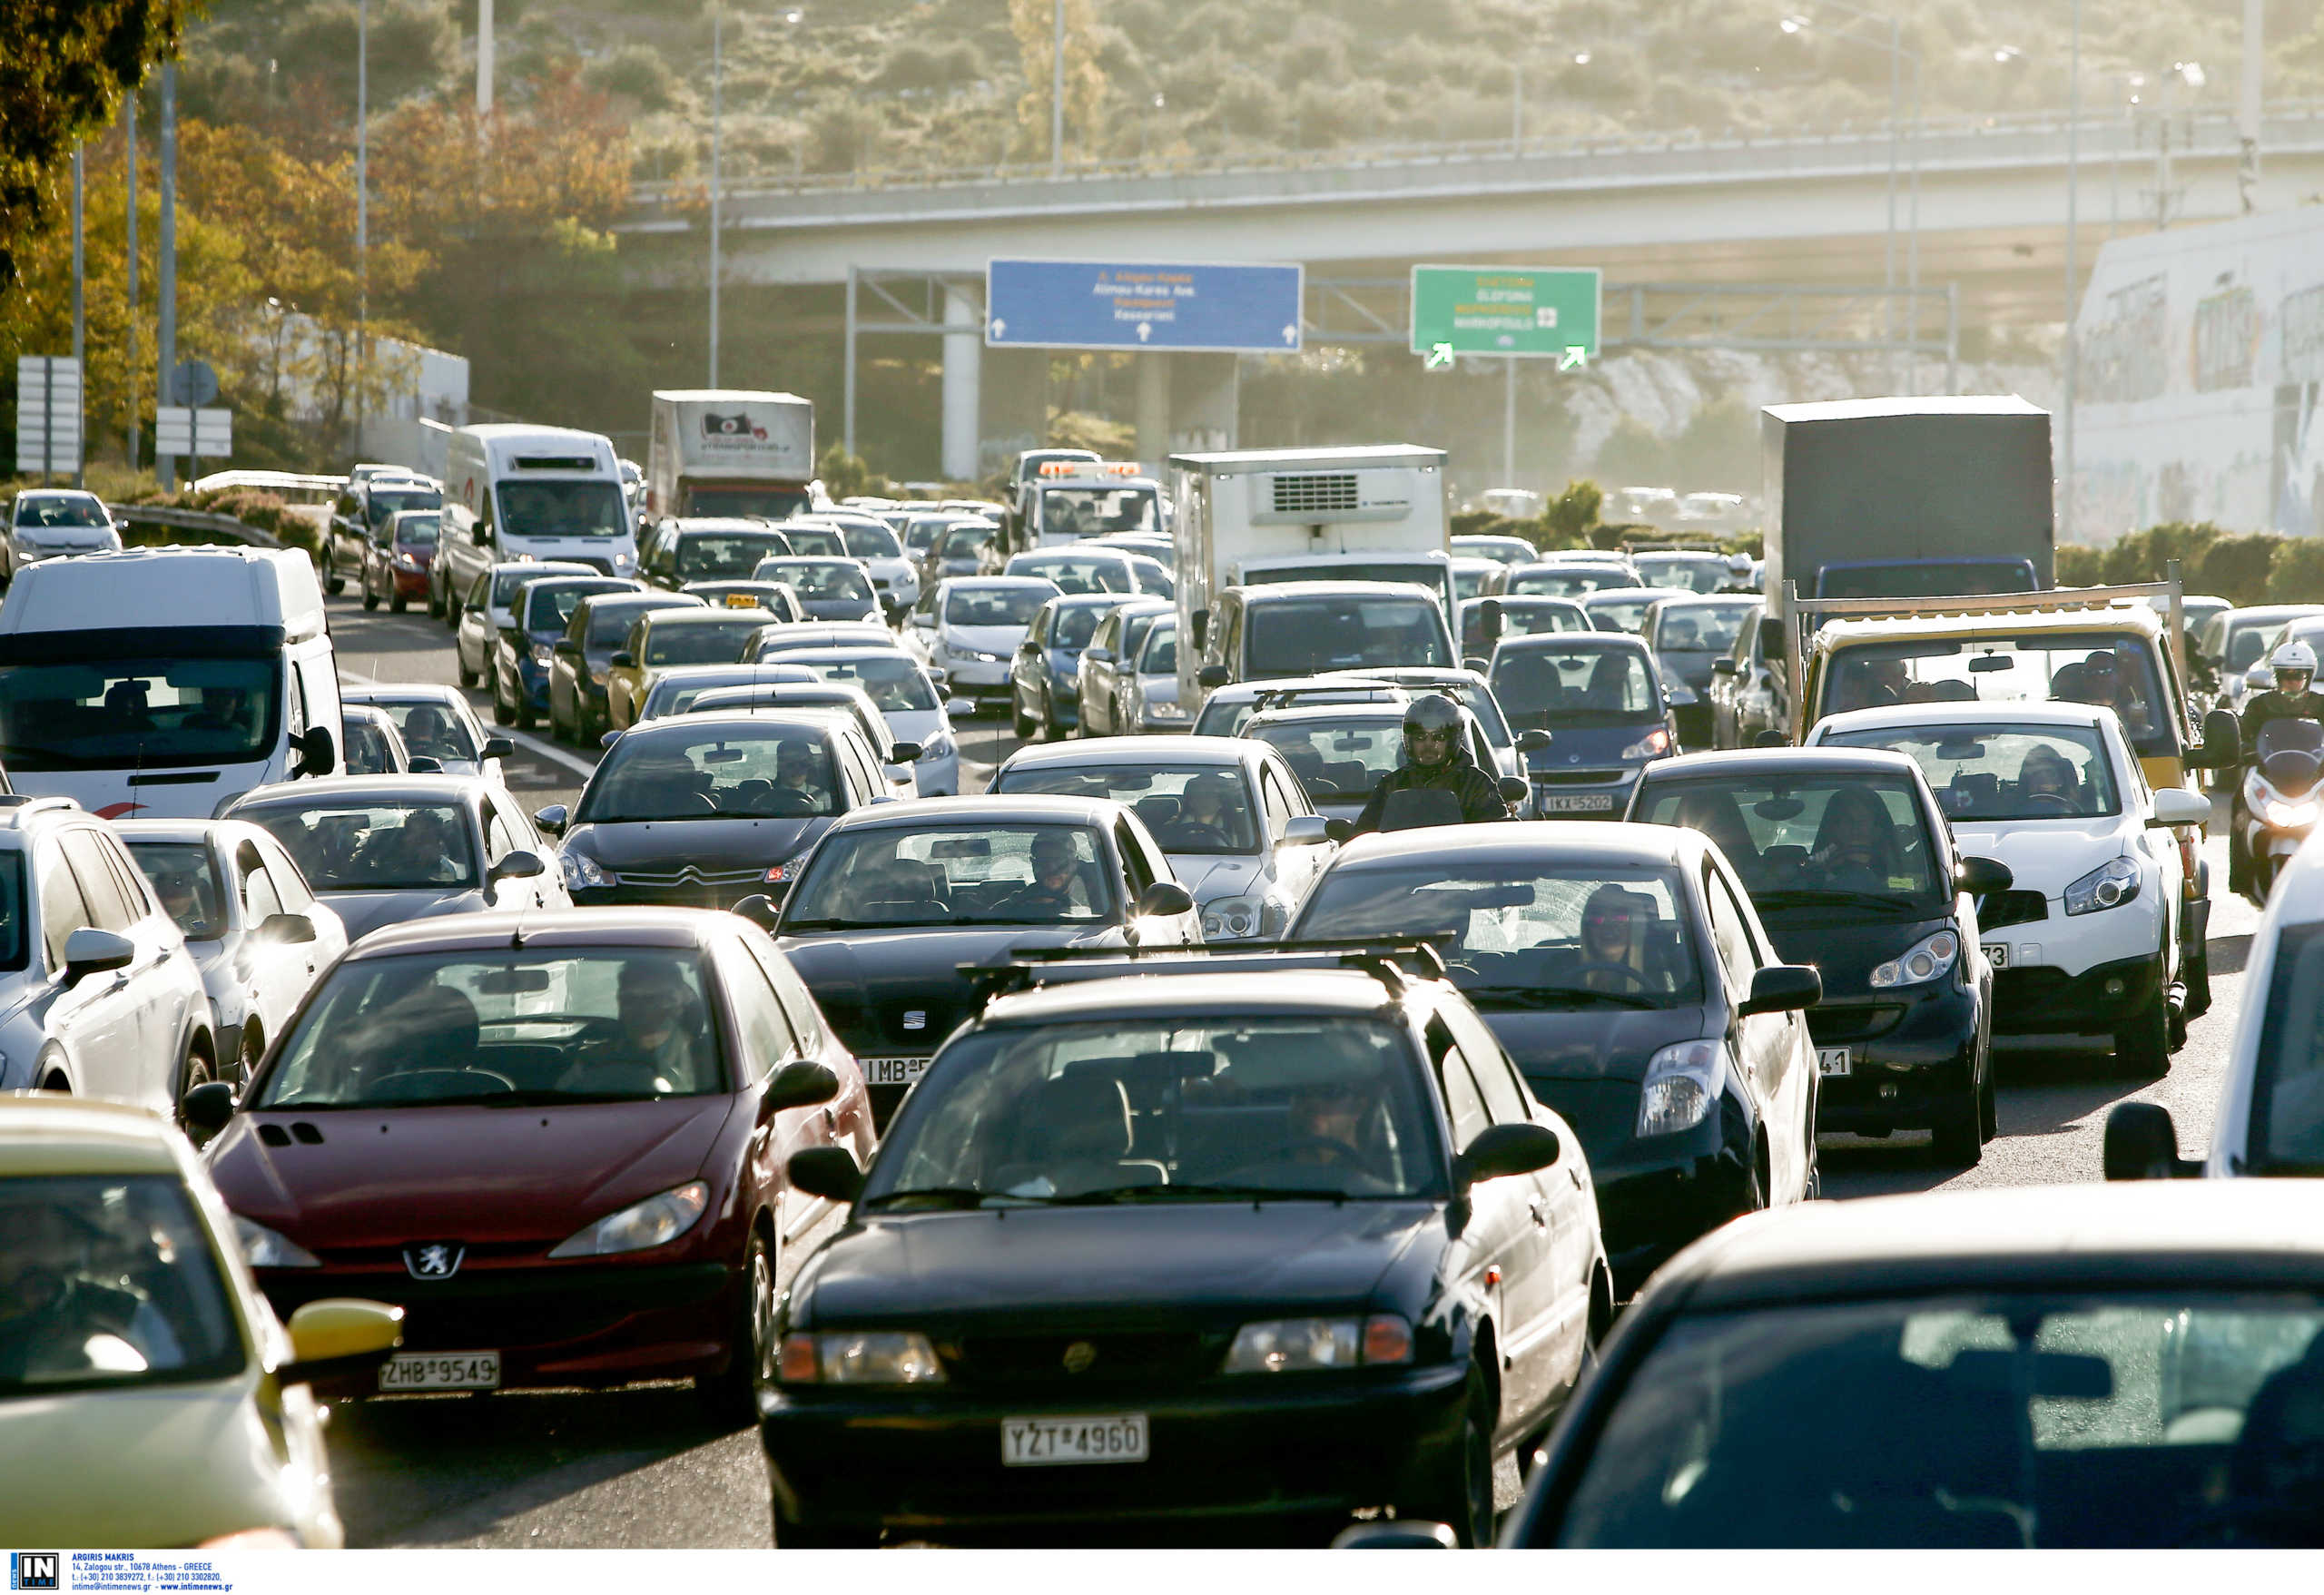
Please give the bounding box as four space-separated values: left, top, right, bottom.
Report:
862 1016 1443 1208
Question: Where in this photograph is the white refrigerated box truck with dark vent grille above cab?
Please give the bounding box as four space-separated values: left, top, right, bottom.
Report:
1169 444 1452 716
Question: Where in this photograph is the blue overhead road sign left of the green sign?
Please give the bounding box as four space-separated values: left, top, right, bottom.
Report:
985 261 1302 353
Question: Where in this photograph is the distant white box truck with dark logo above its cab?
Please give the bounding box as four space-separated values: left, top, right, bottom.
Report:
644 389 821 521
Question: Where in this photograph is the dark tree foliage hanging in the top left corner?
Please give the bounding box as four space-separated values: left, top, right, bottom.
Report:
0 0 186 289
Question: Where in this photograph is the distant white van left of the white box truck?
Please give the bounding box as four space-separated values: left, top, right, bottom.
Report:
435 426 636 593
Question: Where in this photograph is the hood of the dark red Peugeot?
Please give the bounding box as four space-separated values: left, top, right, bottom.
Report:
209 1095 734 1251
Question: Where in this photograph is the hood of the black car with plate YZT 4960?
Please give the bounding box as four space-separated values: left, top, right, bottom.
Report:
795 1200 1443 1333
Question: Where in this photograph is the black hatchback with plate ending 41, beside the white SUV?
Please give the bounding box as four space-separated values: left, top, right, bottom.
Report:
1627 746 2013 1167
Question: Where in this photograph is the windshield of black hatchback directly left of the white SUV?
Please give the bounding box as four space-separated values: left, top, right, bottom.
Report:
1639 774 1952 916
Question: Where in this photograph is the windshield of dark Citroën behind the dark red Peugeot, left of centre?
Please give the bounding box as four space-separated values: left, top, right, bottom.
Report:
576 721 848 825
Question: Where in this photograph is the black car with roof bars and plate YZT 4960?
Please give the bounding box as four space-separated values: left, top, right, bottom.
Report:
760 949 1613 1546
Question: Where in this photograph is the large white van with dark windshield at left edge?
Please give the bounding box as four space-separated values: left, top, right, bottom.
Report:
0 548 344 819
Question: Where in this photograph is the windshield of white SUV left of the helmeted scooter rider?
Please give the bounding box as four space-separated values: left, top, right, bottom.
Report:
1819 725 2122 821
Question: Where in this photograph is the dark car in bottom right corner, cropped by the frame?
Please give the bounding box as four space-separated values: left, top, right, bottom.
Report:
1487 1181 2324 1553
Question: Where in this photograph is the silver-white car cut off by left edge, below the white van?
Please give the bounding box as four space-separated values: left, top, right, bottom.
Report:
0 795 230 1114
